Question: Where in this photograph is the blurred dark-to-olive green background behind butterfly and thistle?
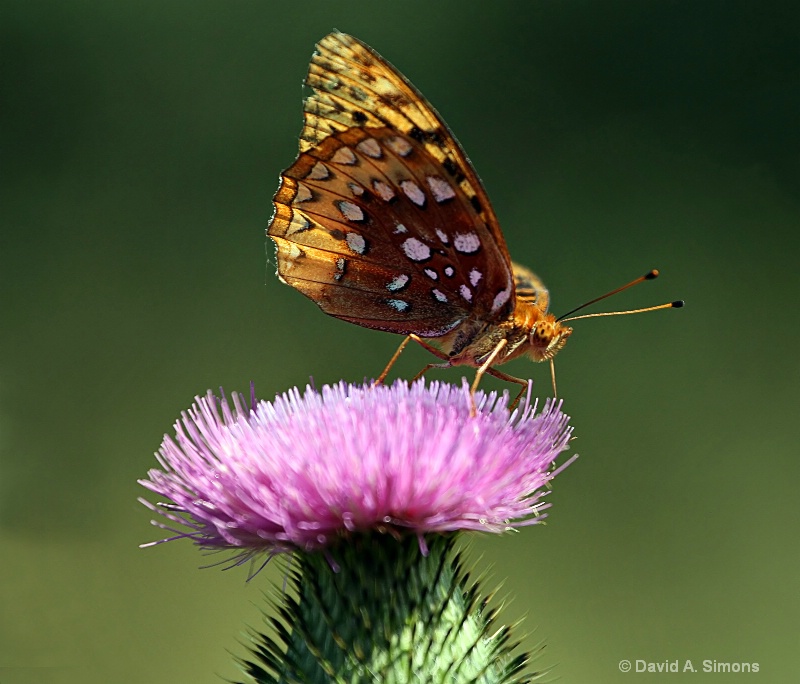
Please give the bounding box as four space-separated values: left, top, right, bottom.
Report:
0 0 800 684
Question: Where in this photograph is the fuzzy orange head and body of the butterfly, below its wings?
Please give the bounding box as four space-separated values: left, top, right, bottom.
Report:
443 300 572 366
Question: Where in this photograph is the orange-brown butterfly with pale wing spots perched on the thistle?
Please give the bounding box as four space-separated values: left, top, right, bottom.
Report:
267 31 674 406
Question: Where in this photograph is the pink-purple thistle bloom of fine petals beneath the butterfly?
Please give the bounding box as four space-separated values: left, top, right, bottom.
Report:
140 381 574 561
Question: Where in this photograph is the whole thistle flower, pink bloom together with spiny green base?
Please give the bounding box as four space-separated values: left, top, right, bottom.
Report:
141 381 571 684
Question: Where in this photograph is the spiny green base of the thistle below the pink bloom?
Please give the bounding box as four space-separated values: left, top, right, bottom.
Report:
238 534 537 684
